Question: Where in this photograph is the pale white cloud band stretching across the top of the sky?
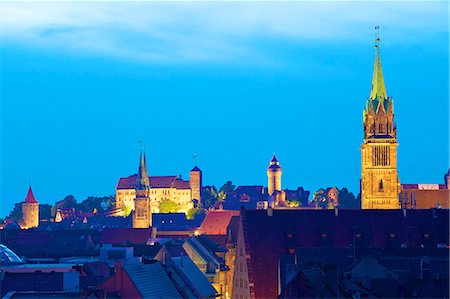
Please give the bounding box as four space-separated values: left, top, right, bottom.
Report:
1 1 448 63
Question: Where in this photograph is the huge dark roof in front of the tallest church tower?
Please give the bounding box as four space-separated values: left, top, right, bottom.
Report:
241 210 449 298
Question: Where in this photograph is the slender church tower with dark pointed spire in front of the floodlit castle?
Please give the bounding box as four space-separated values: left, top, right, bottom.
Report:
133 150 152 228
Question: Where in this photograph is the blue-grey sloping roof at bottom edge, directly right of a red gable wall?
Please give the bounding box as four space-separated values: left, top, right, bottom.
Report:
123 262 182 299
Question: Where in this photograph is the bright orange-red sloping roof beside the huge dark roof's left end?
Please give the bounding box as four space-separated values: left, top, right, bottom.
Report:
200 210 239 235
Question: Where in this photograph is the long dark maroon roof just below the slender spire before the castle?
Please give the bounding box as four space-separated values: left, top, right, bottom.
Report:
100 228 152 244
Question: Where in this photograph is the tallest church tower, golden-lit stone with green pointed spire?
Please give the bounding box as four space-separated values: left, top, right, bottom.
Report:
361 27 400 209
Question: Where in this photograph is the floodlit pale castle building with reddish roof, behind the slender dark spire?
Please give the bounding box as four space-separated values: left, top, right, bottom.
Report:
116 155 202 215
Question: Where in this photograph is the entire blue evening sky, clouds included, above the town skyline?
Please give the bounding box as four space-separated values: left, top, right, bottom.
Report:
0 1 449 216
